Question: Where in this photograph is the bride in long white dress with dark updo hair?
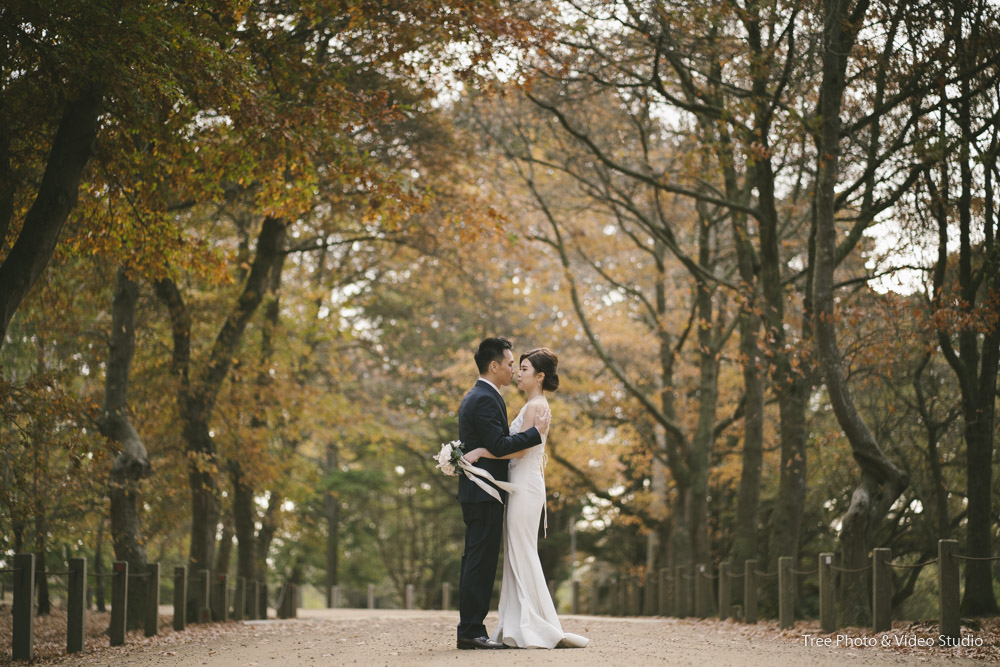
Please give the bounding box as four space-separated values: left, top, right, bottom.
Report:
465 347 590 648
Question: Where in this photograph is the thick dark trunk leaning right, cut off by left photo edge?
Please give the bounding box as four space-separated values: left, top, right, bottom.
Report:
0 84 104 347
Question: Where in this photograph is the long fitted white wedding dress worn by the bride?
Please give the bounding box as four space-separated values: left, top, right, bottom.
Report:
490 405 590 648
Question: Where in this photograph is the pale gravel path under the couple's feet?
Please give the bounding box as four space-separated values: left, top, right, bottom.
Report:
19 609 1000 667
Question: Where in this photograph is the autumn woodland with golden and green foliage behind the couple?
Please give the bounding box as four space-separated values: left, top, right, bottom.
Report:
0 0 1000 624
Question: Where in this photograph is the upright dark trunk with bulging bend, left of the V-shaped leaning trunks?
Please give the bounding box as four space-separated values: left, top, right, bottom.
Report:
98 269 150 629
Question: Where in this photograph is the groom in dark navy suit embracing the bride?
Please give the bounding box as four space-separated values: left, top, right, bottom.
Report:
458 338 552 649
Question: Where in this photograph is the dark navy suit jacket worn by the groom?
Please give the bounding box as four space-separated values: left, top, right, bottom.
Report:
458 381 542 503
